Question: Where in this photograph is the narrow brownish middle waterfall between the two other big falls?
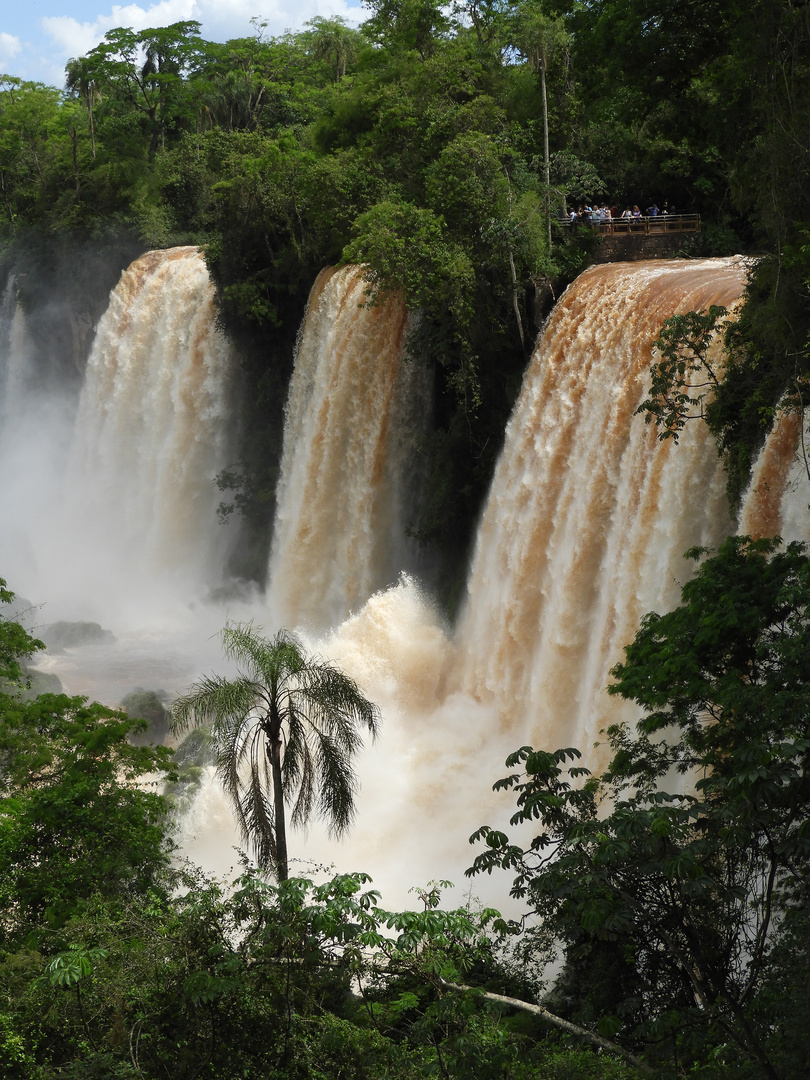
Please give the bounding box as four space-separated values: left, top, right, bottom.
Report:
270 267 429 630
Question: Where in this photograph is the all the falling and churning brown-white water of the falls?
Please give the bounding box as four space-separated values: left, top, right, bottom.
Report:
0 248 810 906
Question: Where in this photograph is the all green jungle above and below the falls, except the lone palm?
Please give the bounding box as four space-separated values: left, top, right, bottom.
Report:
0 0 810 1080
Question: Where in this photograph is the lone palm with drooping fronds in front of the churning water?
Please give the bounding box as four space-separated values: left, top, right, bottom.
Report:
172 623 379 881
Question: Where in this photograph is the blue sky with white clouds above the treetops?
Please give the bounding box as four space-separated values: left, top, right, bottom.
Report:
0 0 368 86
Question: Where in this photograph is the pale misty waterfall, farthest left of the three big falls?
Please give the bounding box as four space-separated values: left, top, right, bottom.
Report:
68 247 239 613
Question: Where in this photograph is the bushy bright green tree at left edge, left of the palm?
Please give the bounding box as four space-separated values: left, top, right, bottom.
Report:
0 583 171 944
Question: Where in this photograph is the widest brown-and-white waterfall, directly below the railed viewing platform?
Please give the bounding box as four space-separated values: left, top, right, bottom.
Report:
455 258 745 748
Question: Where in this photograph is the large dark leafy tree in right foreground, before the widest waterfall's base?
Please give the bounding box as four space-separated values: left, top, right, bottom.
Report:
472 537 810 1080
